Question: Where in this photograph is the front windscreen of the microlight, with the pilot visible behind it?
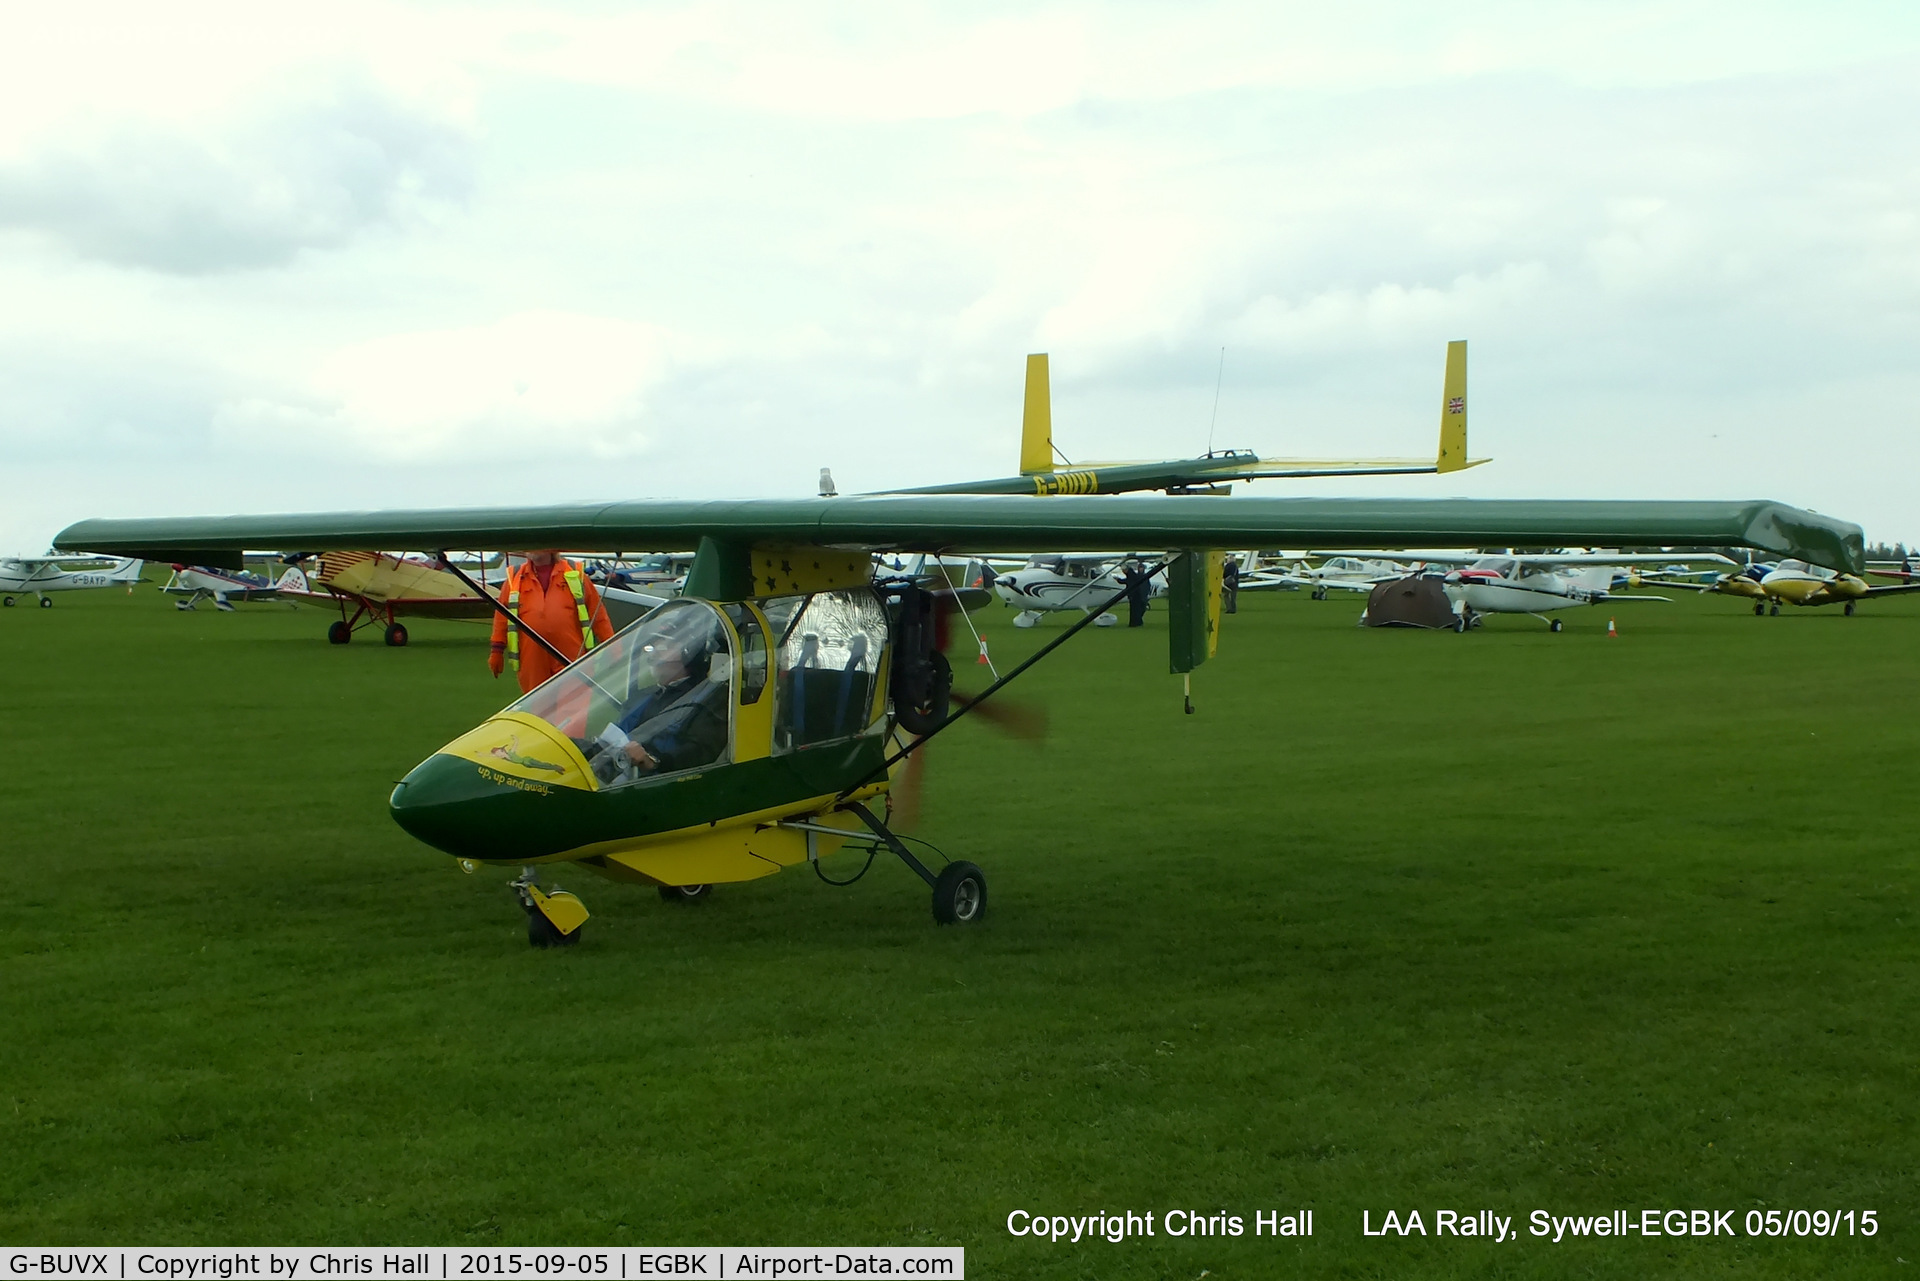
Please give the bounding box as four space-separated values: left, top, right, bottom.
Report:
513 601 733 787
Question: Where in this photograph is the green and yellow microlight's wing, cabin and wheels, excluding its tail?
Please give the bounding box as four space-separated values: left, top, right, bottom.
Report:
54 495 1864 945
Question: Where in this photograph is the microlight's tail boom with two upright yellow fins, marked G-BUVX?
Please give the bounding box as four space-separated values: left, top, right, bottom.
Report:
879 342 1488 495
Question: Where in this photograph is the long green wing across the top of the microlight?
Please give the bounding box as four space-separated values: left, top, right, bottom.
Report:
54 494 1866 572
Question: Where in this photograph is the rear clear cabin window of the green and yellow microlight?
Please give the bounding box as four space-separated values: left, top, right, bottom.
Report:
766 588 887 753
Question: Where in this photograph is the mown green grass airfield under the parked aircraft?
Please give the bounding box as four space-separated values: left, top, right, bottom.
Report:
0 588 1920 1279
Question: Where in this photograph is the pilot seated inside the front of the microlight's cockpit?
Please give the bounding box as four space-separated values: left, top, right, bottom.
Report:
591 622 728 784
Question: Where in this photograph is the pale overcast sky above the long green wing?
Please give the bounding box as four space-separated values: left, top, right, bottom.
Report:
0 0 1920 551
